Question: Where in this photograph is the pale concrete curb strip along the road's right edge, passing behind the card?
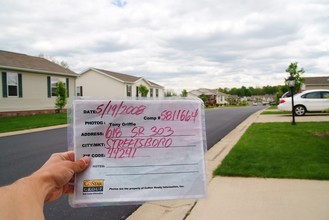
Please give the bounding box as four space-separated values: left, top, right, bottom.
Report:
127 109 264 220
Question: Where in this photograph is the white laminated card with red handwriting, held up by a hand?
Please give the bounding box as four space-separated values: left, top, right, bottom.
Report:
68 99 206 207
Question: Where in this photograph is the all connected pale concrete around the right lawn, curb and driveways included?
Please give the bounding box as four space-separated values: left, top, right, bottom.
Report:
128 111 329 220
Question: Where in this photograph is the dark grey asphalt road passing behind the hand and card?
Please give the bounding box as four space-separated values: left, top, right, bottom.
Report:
0 106 262 220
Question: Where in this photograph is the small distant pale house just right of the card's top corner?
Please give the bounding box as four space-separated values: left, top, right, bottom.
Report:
188 88 229 105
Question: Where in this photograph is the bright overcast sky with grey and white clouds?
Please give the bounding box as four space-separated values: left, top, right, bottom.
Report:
0 0 329 92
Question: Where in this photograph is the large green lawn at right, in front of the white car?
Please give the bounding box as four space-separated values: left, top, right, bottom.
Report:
214 122 329 180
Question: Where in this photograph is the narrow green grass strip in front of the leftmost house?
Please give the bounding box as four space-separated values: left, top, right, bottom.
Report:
0 113 67 133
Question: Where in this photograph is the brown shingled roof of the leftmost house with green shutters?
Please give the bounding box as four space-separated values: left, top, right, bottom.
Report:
0 50 77 76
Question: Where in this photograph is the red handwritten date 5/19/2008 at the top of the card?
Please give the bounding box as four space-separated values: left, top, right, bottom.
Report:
96 101 146 118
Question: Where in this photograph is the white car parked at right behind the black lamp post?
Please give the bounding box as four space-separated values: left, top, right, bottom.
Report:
278 89 329 116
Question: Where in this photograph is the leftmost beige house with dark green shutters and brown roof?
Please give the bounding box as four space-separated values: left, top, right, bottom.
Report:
0 50 78 116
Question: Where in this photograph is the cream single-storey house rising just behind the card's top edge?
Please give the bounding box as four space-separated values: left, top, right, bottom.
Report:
77 68 164 99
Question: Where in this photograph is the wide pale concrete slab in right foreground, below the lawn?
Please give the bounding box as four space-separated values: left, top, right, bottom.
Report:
186 177 329 220
